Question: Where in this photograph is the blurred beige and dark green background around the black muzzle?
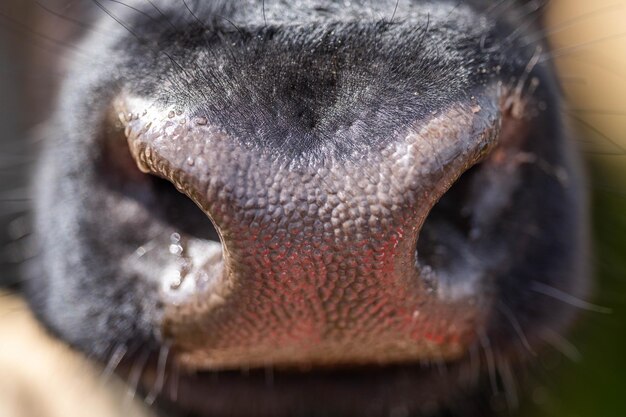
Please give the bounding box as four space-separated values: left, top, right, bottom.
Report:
0 0 626 417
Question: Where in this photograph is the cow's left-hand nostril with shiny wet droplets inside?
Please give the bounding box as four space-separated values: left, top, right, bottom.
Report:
97 105 228 306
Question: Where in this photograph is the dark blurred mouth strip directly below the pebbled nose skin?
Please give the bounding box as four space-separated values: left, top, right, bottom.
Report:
114 350 481 417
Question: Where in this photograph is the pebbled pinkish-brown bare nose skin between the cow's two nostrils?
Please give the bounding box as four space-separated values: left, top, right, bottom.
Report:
115 89 499 368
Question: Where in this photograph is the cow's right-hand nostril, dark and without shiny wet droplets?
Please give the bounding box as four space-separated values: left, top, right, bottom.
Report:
416 112 533 299
